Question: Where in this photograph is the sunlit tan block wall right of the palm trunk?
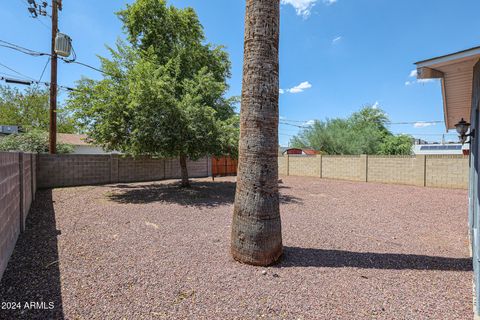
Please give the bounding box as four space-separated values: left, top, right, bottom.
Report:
278 155 469 189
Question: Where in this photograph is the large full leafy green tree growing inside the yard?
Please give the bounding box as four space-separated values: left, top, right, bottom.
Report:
69 0 238 186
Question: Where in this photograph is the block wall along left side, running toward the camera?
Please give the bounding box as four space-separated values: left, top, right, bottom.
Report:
0 152 36 278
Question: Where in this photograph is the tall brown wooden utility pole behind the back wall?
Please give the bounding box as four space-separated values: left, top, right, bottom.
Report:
49 0 62 154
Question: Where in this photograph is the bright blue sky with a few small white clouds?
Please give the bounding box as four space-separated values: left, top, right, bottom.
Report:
0 0 480 145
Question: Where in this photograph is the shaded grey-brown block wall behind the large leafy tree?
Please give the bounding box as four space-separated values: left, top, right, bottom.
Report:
37 154 211 188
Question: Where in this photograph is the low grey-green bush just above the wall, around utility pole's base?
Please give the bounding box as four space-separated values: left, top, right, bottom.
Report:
0 129 73 154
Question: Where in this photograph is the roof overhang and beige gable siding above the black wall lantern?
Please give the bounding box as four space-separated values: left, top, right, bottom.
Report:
415 47 480 129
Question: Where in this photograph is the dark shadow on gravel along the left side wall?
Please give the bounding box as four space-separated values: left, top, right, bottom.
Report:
0 190 64 319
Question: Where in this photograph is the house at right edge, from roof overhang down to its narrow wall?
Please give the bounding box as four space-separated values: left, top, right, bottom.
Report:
416 47 480 319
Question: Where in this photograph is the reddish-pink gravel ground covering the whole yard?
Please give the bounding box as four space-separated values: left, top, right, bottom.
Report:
0 177 473 320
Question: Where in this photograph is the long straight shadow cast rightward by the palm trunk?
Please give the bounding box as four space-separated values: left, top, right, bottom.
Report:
276 247 472 271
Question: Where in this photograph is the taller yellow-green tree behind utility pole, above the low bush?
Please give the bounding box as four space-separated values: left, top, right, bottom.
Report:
0 86 77 133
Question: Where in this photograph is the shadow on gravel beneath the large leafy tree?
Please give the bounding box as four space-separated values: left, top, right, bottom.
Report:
106 181 301 207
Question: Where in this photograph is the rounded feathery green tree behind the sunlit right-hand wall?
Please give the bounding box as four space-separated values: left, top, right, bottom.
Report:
291 106 392 155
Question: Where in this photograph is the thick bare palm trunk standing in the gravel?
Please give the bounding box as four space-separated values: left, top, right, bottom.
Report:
231 0 283 266
